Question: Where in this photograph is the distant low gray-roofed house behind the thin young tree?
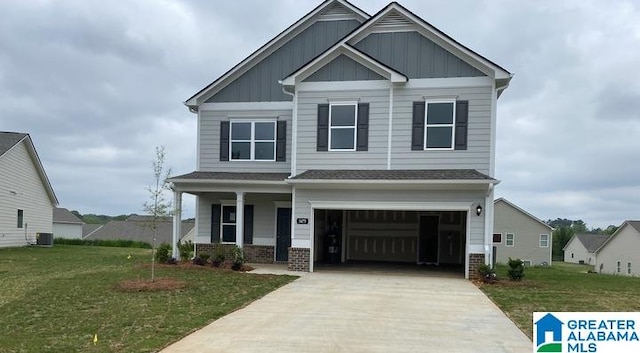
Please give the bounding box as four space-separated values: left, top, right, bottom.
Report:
85 215 194 244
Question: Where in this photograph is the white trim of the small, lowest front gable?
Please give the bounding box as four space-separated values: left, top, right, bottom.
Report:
281 42 409 86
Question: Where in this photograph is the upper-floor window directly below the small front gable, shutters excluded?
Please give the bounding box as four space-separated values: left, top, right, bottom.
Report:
329 102 358 151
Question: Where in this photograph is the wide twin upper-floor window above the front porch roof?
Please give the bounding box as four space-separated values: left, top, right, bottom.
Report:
229 121 276 161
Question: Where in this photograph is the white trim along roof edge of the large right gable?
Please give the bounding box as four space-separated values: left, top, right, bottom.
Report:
343 2 511 80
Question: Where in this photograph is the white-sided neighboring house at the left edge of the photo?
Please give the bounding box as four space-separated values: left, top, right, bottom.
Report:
0 132 58 247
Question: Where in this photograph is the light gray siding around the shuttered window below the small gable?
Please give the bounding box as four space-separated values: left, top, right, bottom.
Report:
297 86 389 173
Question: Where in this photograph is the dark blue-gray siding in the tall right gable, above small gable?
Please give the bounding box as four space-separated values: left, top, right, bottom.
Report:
355 32 485 78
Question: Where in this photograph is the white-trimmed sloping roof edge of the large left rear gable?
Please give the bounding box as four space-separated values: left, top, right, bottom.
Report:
184 0 369 108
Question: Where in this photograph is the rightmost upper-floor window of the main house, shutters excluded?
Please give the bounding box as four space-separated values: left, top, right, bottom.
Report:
424 100 456 150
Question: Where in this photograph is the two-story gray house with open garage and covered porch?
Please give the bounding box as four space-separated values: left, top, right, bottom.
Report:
170 0 511 278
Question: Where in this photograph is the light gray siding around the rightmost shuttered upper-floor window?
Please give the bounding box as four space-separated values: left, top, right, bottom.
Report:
391 87 491 174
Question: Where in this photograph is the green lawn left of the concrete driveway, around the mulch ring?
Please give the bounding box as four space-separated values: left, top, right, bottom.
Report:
0 245 296 352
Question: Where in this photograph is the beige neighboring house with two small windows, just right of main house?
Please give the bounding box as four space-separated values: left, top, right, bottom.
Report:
493 198 553 266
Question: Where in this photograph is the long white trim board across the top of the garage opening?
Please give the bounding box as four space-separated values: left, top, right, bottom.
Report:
309 200 474 211
